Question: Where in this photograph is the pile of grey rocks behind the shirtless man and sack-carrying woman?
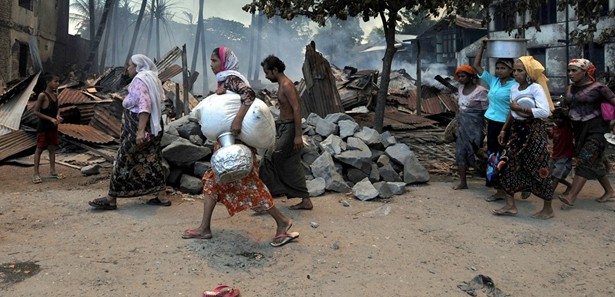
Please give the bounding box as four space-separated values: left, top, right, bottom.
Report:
156 110 429 200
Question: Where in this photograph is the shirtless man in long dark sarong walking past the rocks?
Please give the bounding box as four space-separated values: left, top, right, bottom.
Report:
259 55 313 210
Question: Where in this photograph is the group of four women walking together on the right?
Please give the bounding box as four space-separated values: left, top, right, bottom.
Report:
454 40 615 219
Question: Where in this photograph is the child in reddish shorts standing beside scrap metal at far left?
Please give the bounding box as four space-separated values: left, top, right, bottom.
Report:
32 74 62 184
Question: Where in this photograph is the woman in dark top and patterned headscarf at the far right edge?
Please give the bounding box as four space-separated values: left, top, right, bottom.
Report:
559 59 615 206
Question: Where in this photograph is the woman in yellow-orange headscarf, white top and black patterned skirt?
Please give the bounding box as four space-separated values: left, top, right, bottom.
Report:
493 56 553 219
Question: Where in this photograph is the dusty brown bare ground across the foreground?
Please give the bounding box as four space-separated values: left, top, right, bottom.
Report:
0 151 615 296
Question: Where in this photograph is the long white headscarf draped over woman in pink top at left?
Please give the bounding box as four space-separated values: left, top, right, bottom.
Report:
130 54 164 136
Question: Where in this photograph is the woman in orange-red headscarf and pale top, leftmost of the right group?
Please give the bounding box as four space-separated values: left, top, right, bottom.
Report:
453 65 489 190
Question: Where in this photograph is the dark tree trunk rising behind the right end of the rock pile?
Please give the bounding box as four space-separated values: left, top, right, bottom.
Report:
374 10 397 133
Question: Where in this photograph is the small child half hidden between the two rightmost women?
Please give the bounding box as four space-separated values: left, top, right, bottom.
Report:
549 109 574 195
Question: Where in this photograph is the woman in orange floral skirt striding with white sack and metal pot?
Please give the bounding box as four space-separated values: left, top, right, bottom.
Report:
182 47 299 247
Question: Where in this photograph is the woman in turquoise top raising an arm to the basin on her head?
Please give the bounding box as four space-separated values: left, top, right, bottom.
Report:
472 39 517 202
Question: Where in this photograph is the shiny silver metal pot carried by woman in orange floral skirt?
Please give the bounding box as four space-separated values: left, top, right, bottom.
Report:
211 132 252 183
